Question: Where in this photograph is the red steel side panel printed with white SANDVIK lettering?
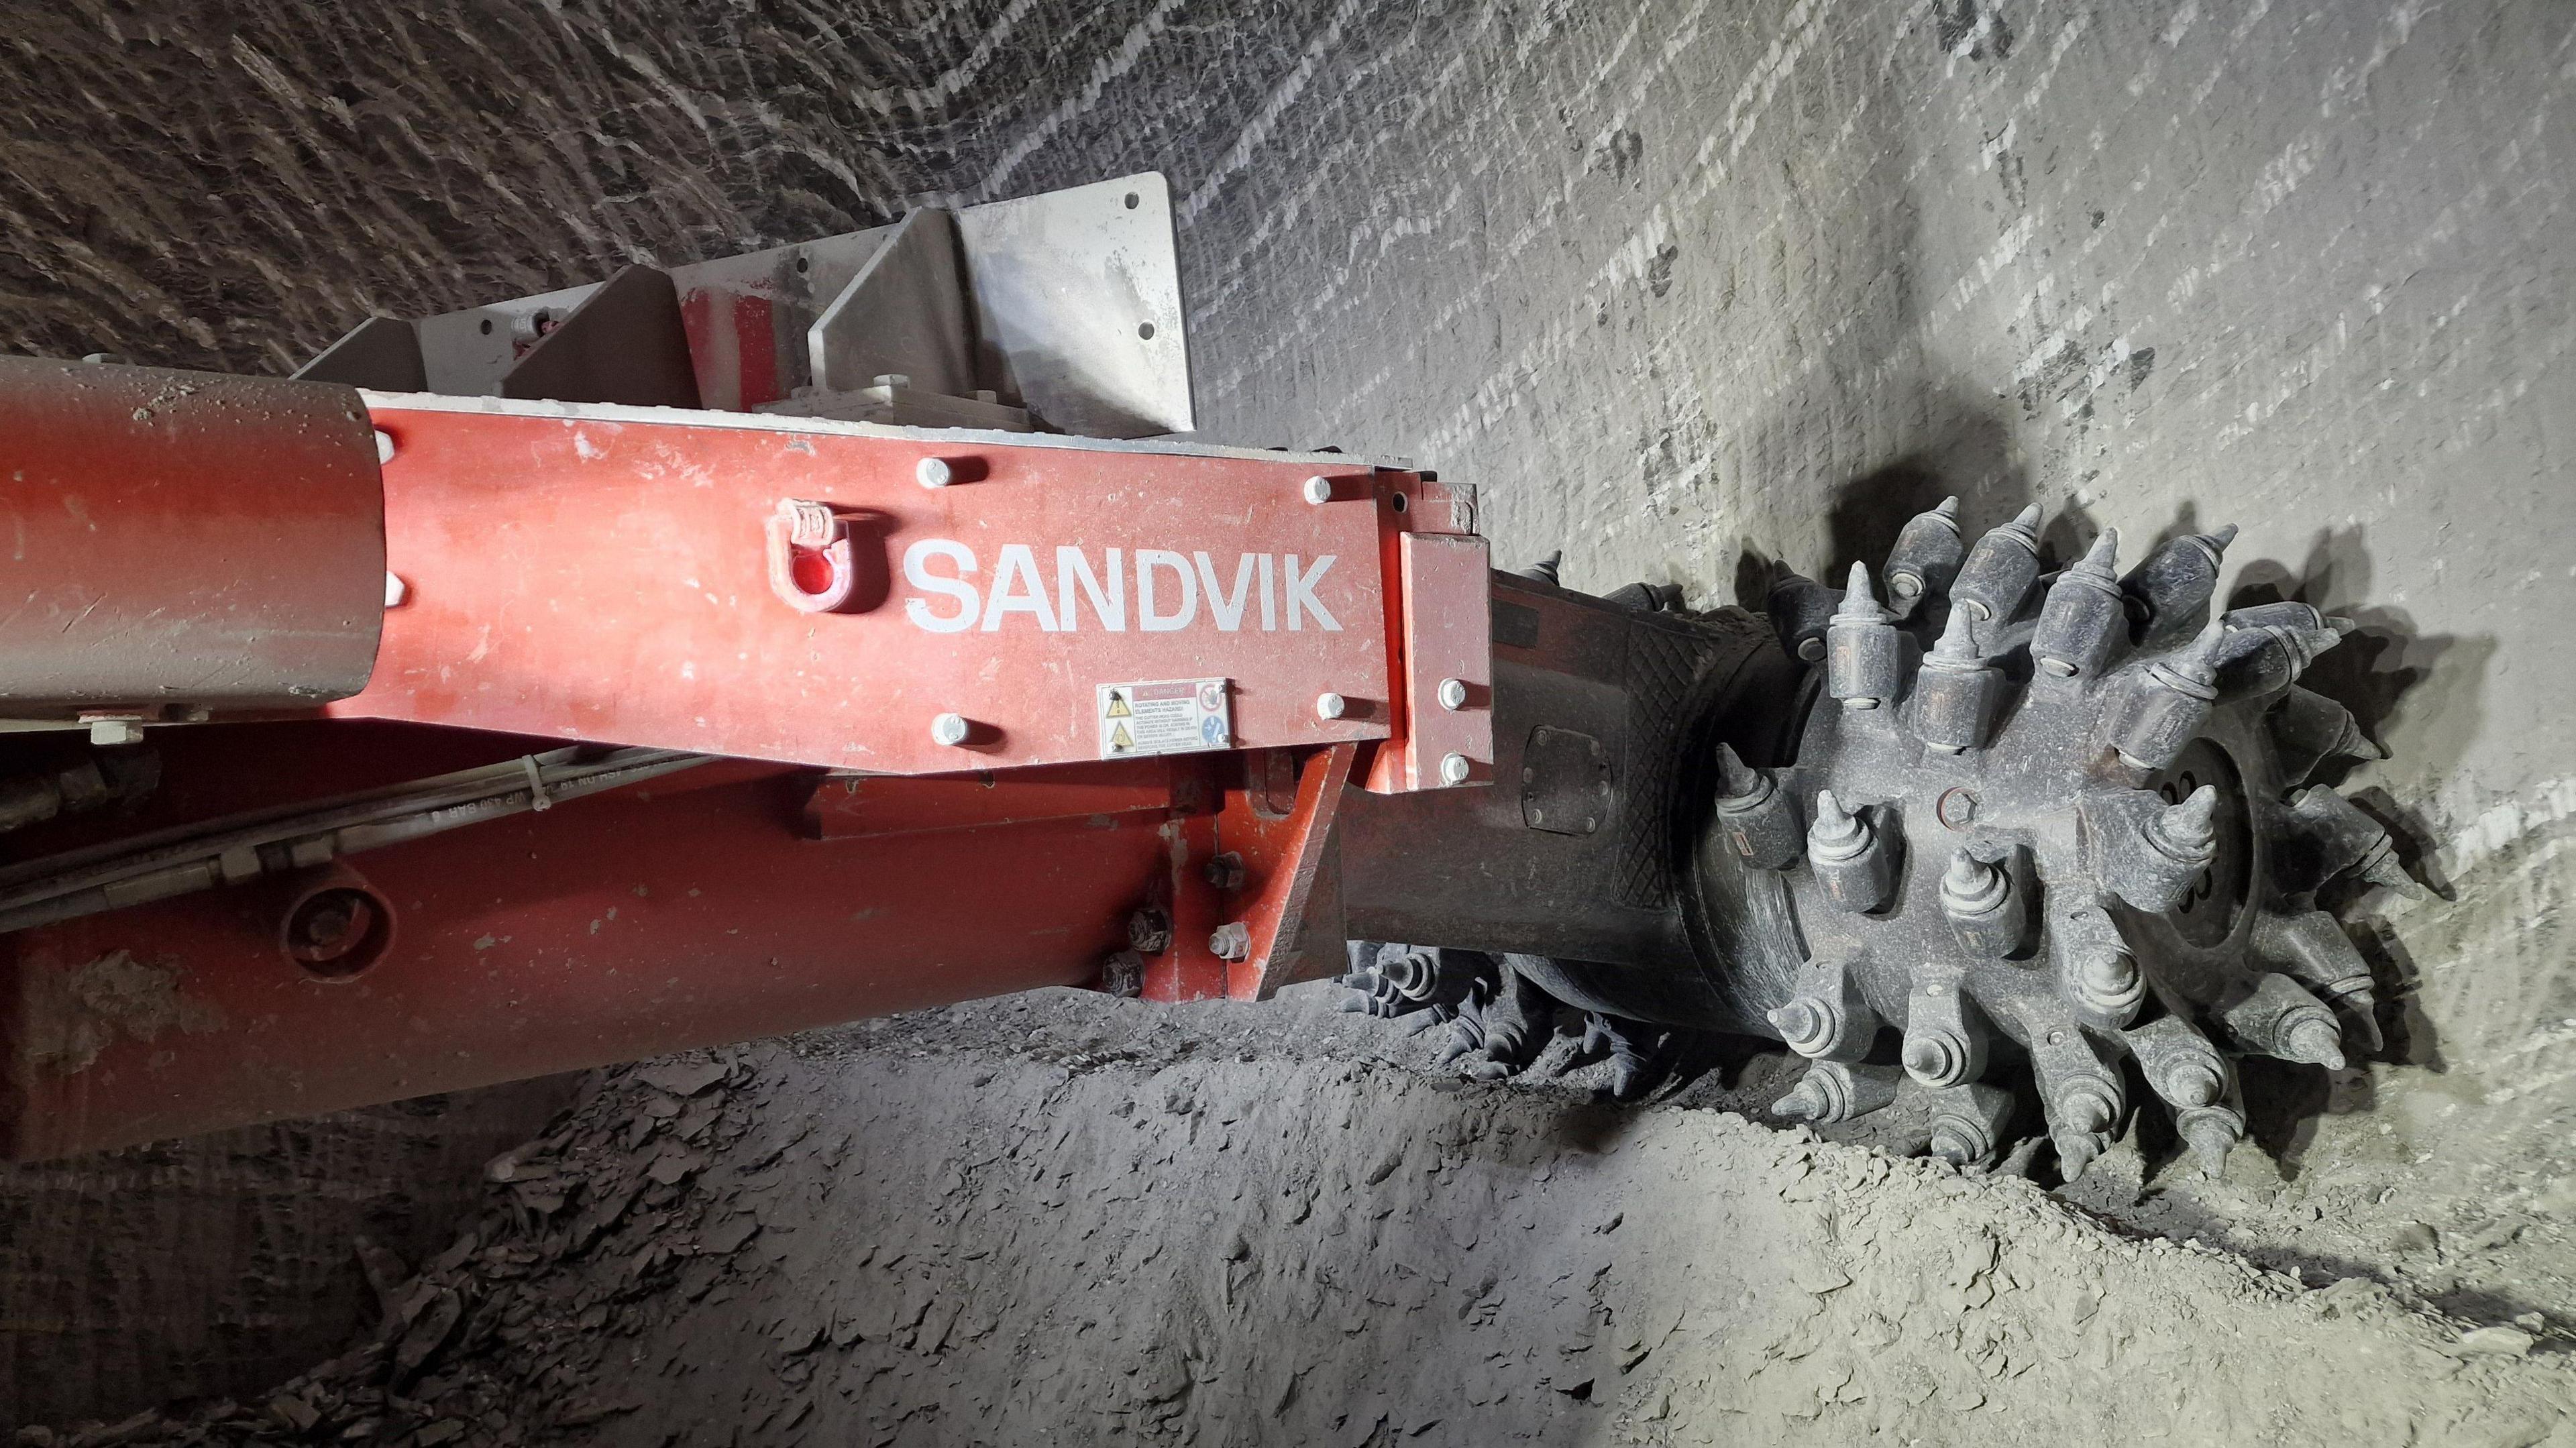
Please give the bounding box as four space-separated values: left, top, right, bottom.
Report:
332 399 1421 773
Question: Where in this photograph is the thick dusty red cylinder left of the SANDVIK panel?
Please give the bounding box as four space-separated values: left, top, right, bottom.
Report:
0 358 384 716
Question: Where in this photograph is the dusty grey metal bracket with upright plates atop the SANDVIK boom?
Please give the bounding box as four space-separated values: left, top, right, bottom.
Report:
299 172 1195 438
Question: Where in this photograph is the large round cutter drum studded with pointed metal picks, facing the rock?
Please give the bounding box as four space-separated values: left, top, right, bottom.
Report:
1693 510 2411 1175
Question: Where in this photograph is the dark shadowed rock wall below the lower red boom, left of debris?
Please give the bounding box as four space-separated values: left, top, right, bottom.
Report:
0 1077 577 1425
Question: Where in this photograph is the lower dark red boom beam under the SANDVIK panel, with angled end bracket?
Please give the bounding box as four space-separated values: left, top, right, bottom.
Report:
0 706 1391 1157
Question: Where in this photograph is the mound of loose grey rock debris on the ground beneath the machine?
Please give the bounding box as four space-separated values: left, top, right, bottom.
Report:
18 1007 2576 1448
